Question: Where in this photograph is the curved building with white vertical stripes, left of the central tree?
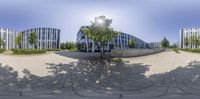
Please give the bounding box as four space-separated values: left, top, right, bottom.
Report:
20 28 60 49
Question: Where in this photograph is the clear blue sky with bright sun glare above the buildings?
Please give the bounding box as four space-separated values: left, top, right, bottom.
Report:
0 0 200 43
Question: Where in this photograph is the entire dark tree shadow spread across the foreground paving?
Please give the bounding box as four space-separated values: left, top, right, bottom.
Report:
0 59 200 98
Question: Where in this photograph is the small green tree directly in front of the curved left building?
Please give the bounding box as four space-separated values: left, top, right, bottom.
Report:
28 32 37 49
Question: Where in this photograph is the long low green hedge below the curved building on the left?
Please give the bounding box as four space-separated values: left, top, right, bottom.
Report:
12 49 46 54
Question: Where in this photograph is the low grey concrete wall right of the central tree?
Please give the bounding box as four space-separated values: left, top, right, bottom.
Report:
111 49 164 57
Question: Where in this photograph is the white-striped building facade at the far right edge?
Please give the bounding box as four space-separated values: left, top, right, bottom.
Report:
179 28 200 48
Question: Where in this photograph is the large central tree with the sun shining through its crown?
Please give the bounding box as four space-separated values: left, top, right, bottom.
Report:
81 16 119 58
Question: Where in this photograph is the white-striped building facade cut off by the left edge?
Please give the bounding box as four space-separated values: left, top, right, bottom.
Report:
0 27 17 50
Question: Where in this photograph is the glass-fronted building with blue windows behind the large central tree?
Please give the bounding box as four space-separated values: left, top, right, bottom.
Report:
76 26 157 52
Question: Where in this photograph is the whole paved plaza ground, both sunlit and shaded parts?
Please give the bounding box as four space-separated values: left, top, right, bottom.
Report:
0 51 200 99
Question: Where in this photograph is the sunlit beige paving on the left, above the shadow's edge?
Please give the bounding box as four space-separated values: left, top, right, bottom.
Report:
0 53 76 77
